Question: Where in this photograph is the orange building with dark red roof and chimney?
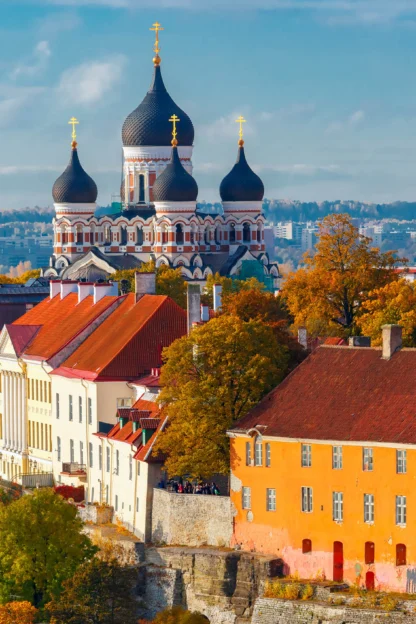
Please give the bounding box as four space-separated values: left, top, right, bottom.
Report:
229 325 416 592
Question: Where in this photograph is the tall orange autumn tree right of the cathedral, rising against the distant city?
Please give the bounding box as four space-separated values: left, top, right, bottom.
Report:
282 214 405 336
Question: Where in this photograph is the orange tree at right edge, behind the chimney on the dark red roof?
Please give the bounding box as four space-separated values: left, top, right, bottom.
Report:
357 279 416 347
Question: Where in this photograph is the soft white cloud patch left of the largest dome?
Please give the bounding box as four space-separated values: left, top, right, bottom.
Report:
58 54 126 106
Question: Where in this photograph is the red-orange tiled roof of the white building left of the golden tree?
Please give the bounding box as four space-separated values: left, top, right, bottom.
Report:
54 293 186 381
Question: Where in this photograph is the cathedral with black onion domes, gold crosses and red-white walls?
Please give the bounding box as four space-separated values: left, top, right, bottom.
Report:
44 23 279 283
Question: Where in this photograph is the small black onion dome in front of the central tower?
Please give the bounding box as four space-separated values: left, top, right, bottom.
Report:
153 147 198 202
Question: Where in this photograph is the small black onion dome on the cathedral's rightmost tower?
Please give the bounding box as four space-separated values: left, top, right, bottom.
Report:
220 147 264 201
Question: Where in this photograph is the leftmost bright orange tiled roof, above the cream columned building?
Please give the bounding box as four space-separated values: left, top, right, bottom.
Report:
13 293 118 360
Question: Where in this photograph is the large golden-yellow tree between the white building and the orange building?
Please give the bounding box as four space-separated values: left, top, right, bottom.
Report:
157 315 288 477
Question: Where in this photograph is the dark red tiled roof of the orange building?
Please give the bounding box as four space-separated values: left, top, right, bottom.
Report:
233 346 416 444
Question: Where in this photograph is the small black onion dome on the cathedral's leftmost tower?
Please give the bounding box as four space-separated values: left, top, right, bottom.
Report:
52 148 98 204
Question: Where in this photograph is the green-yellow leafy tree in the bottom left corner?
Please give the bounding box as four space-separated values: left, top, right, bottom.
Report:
0 489 96 607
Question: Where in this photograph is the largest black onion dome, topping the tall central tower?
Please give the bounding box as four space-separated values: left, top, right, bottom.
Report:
121 66 194 147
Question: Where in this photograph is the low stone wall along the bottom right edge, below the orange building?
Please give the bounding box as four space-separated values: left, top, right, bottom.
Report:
251 598 416 624
